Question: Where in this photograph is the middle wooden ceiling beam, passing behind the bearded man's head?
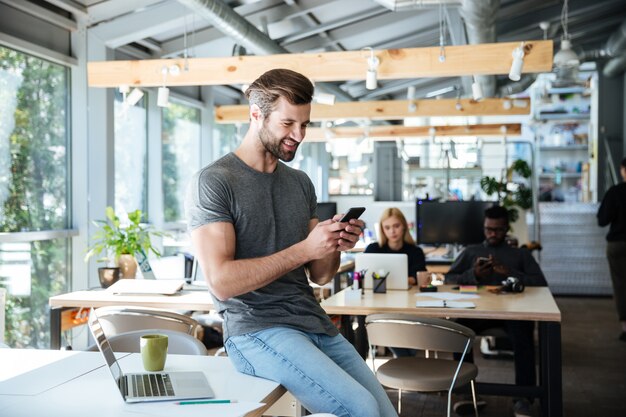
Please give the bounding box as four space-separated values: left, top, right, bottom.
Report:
215 98 530 123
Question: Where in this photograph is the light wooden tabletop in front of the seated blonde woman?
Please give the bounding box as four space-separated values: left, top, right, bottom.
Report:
321 285 561 322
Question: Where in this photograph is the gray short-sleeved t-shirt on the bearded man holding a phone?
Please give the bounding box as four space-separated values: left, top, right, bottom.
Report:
185 153 338 340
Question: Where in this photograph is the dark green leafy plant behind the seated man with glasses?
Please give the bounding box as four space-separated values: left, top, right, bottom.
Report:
480 159 533 223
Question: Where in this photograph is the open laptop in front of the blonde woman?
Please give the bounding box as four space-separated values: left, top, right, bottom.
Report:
354 253 409 290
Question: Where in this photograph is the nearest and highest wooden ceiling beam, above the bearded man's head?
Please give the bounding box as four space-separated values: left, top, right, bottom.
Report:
87 40 553 87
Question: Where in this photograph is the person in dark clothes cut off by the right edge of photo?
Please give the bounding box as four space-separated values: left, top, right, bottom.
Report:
597 158 626 342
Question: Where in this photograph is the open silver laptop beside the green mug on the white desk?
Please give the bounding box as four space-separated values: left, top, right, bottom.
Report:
89 309 214 403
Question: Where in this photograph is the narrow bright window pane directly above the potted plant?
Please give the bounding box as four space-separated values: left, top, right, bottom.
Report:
114 93 148 214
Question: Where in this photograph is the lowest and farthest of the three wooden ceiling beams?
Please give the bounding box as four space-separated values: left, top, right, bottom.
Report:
305 123 522 142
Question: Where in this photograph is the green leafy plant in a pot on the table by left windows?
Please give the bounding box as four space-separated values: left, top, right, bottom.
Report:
85 207 164 278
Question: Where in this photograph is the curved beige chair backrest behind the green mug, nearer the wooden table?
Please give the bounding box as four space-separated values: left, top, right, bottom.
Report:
97 306 202 337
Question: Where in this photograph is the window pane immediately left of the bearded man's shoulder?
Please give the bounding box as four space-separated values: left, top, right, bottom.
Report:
161 102 200 222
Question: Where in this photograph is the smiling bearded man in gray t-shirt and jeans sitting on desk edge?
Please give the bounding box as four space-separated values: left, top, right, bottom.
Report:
186 69 397 417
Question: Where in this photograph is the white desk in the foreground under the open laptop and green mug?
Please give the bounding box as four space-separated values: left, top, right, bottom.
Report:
0 349 285 417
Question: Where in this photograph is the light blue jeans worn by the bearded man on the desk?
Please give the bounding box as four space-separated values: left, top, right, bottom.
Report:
225 327 398 417
